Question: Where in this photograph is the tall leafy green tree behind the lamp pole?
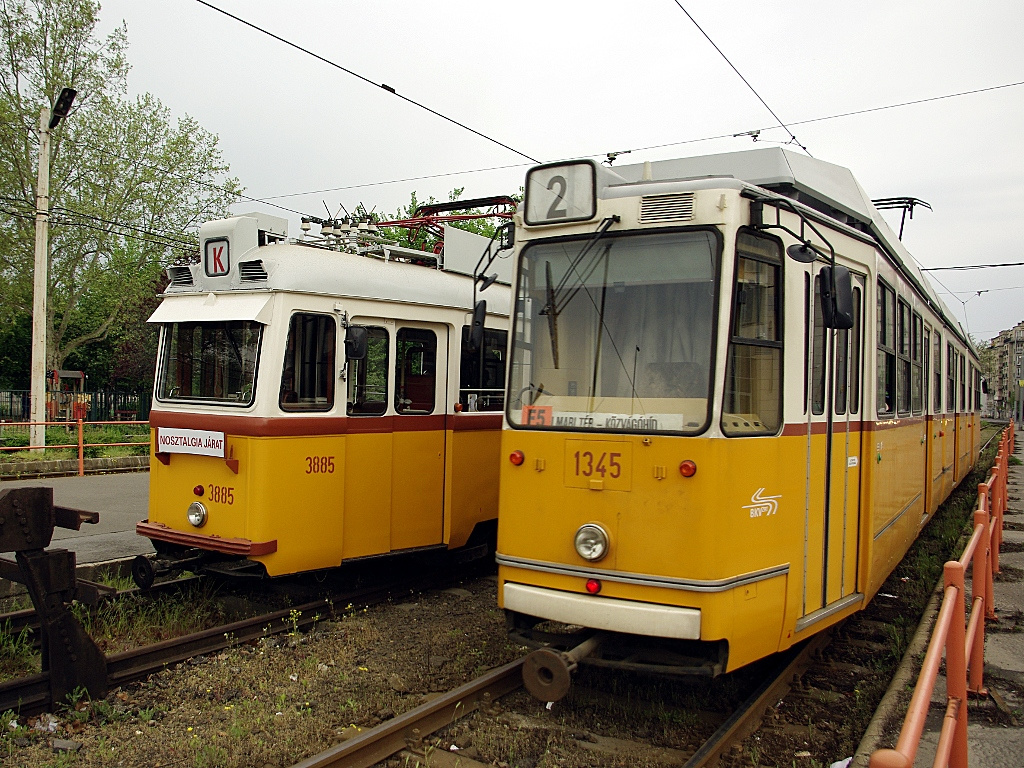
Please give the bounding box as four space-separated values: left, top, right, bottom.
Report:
0 0 241 385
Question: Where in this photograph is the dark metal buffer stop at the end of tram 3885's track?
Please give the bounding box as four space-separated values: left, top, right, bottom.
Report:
0 487 106 705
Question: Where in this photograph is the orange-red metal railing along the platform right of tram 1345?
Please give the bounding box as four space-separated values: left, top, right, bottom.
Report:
868 422 1016 768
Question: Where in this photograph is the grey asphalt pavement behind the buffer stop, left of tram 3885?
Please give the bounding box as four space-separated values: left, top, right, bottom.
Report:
0 472 154 565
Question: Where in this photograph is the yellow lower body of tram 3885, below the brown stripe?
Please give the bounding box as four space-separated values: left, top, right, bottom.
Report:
148 415 500 577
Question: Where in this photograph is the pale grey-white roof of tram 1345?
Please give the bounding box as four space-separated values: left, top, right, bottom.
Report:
598 147 968 348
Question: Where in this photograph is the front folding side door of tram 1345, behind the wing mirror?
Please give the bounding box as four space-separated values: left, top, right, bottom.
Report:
803 267 864 625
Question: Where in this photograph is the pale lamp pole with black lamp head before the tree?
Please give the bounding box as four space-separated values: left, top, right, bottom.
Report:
29 88 77 452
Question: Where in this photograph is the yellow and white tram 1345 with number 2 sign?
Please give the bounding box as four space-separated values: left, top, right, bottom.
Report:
497 148 981 700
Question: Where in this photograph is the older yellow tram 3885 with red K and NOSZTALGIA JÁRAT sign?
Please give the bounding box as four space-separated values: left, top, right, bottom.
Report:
133 200 514 586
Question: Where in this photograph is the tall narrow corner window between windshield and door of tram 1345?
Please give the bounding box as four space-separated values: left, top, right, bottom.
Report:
722 231 782 436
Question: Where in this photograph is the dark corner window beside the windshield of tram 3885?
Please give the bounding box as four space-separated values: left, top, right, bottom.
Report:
279 313 337 411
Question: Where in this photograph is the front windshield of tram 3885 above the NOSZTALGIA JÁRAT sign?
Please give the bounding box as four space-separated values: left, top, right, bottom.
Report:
157 321 263 406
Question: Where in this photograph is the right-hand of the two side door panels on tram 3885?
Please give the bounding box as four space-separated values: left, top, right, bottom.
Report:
391 322 449 550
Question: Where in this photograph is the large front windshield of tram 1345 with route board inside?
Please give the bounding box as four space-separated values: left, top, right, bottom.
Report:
508 230 719 433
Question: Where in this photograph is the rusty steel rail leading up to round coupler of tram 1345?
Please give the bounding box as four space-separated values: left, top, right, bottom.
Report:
293 658 523 768
